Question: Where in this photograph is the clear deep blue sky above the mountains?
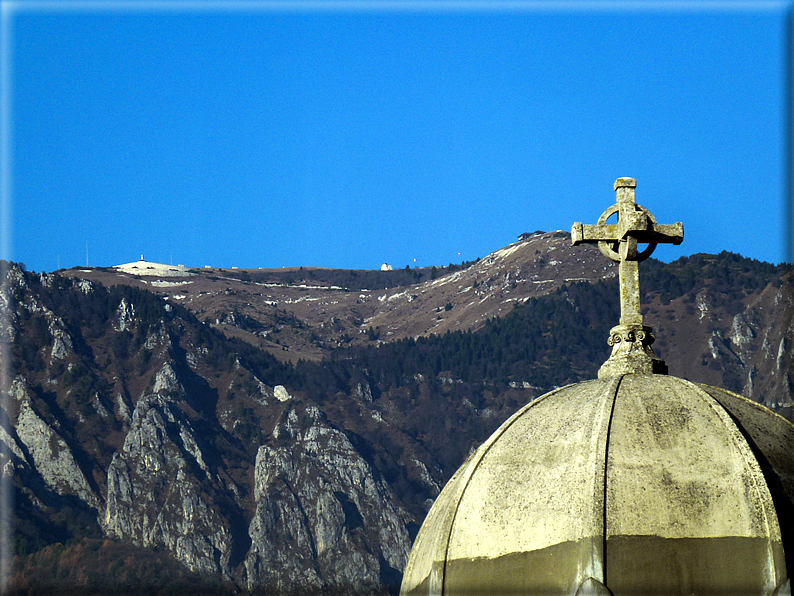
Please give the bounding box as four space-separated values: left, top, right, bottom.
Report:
3 1 786 271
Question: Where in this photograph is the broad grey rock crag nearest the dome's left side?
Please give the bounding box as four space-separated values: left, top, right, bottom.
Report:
245 406 410 593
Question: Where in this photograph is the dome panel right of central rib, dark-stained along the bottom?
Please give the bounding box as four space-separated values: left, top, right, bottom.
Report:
605 375 786 594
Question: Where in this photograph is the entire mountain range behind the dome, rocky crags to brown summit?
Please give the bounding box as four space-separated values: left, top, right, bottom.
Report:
0 232 794 593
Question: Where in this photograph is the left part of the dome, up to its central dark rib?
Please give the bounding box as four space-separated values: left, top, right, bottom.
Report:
404 376 622 594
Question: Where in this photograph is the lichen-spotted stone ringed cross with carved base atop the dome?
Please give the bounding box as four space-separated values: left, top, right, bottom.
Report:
571 178 684 378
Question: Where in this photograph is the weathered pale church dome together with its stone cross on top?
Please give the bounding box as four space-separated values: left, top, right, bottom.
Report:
401 178 794 596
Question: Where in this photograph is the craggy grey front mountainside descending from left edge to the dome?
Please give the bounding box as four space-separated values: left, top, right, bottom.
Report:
0 269 424 594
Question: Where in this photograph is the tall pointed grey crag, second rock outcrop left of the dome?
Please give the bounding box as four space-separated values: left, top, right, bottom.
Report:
101 364 232 576
